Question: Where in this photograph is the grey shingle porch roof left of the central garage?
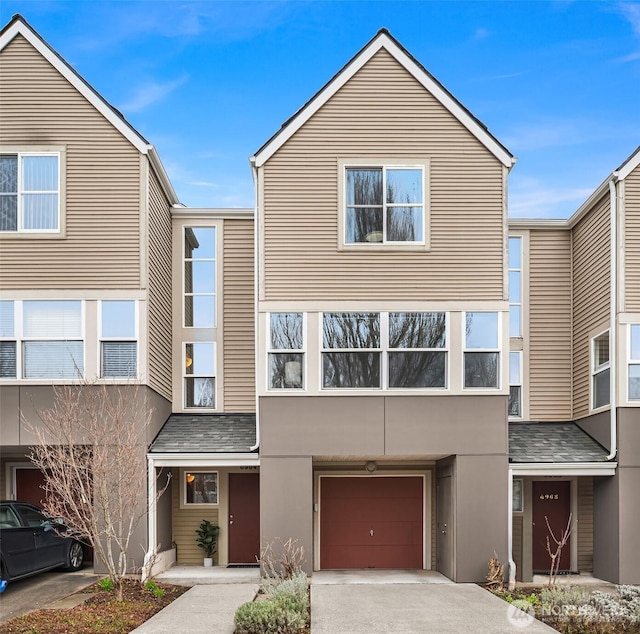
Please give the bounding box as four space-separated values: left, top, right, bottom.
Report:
149 414 256 453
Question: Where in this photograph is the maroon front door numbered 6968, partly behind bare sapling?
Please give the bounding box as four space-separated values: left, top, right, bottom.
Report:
532 480 571 573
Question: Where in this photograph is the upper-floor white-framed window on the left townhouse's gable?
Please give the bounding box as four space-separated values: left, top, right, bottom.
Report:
0 152 60 233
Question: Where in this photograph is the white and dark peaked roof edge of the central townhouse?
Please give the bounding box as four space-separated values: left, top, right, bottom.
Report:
249 29 515 168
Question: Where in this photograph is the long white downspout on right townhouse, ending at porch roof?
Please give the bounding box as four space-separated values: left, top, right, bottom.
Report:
607 178 618 460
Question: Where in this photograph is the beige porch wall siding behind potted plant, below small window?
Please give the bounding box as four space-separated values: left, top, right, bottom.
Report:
171 469 222 566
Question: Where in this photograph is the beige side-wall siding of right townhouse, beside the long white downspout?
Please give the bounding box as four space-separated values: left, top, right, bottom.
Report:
572 192 611 418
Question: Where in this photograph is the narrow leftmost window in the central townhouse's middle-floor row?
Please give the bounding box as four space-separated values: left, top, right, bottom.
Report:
268 313 305 390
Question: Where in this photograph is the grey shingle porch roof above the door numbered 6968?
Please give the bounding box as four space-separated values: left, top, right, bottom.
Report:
509 422 609 462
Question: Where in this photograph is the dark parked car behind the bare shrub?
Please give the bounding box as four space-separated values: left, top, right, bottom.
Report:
0 501 84 592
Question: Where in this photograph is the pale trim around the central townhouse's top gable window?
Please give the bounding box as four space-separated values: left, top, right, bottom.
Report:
338 157 431 253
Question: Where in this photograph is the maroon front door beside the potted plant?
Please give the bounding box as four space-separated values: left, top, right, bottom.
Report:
229 473 260 564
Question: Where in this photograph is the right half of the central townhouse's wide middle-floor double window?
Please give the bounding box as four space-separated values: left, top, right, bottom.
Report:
388 313 447 388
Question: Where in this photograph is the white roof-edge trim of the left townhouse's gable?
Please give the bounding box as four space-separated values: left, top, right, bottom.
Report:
0 14 180 205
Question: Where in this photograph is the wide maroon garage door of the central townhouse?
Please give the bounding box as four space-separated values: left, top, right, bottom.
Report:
320 476 424 569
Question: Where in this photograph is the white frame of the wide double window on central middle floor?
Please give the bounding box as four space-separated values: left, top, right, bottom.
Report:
318 309 451 394
